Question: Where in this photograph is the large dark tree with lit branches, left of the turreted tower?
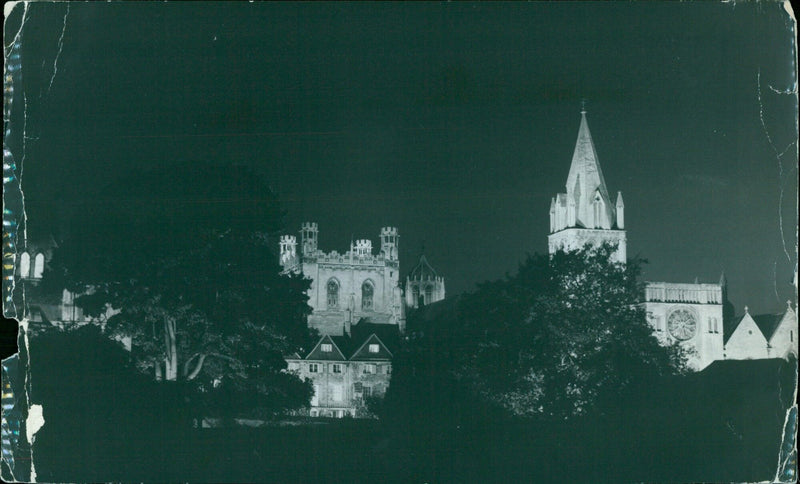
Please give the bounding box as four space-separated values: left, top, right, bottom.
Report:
43 163 312 412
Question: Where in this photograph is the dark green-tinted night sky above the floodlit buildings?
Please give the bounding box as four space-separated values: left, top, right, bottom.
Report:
6 2 797 312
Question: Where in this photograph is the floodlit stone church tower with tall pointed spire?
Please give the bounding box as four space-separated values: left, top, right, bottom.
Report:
547 109 627 263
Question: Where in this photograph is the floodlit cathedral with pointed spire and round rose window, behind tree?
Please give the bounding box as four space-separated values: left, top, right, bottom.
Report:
548 110 798 370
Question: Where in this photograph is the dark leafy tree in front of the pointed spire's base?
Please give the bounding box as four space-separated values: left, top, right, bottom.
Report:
400 245 686 418
